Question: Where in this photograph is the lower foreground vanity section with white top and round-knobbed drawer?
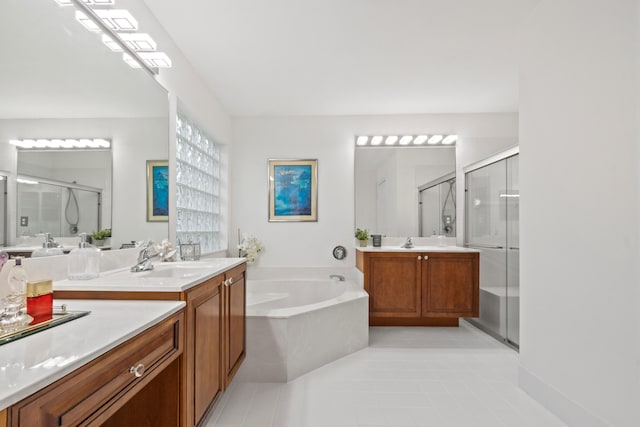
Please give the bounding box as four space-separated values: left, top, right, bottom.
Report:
0 300 185 427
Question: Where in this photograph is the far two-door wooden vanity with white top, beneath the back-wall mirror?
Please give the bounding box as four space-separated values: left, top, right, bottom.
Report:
356 246 480 326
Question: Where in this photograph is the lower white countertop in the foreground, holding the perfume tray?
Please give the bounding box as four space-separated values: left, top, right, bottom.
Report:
0 300 185 410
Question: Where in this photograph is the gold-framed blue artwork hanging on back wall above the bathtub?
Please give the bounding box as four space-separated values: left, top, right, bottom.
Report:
269 159 318 222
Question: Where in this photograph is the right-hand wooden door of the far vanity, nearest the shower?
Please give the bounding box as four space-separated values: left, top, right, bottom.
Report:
422 252 479 317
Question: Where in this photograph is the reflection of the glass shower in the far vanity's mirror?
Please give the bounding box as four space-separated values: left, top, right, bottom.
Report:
418 173 456 237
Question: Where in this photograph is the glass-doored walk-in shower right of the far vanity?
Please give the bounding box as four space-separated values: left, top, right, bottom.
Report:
464 148 520 347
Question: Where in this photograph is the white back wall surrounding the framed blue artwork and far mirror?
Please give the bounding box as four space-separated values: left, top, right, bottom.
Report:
230 114 518 266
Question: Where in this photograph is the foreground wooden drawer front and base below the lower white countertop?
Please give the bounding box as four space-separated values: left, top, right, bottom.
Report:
8 311 185 427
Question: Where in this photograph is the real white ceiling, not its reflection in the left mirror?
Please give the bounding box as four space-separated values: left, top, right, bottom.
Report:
144 0 537 116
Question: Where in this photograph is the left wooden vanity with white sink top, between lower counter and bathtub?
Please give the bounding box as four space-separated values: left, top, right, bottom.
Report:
54 258 246 426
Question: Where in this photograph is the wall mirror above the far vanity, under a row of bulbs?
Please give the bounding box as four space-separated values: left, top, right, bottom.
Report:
355 146 456 241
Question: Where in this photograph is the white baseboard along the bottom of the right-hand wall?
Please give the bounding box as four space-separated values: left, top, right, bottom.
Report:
518 366 612 427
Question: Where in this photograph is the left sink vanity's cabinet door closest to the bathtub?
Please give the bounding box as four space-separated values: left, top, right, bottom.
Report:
225 264 246 386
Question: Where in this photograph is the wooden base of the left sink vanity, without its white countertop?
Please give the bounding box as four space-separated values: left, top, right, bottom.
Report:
54 263 247 427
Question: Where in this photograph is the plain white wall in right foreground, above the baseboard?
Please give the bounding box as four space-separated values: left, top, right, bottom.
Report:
520 0 640 427
